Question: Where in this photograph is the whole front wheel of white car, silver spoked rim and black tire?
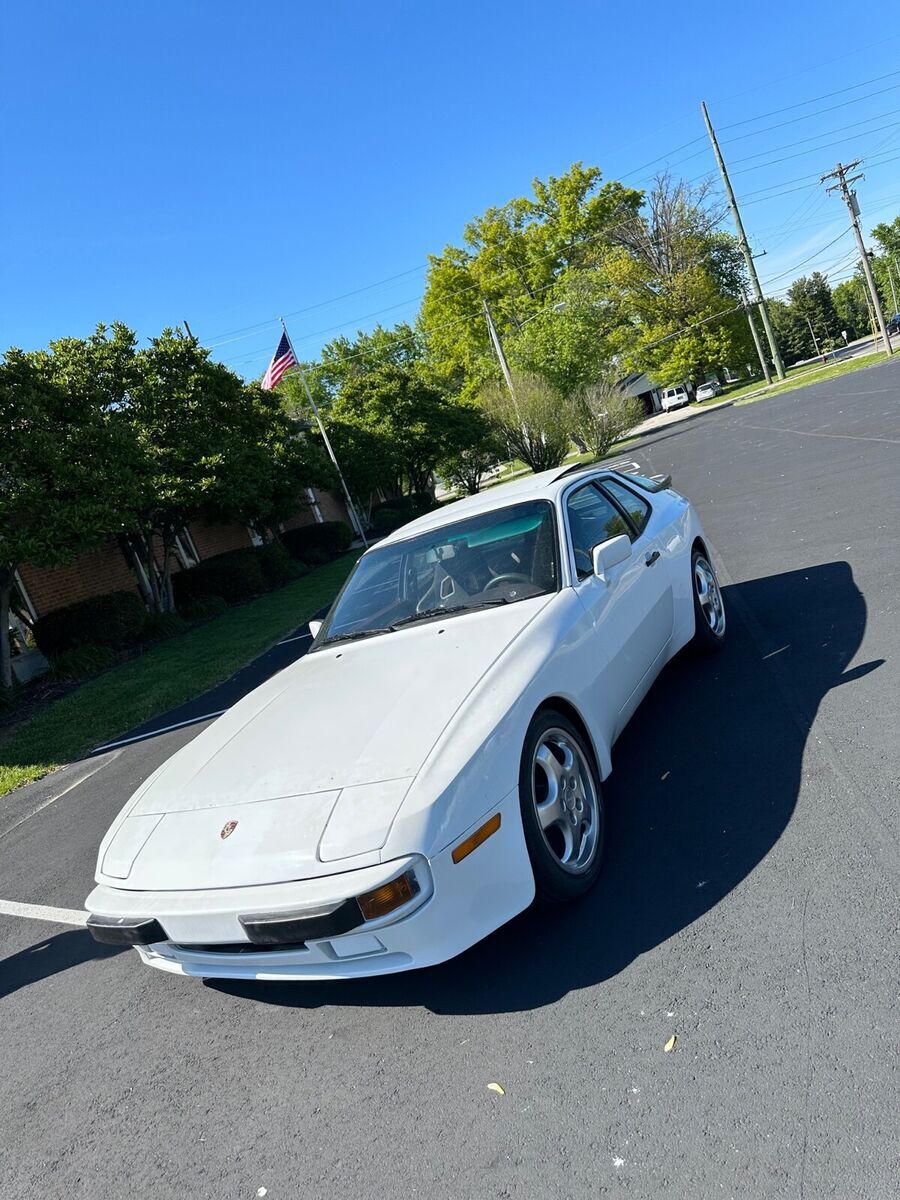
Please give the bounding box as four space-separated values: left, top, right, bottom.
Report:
518 709 604 904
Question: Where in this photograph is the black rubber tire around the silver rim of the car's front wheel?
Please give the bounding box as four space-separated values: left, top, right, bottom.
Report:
518 708 606 904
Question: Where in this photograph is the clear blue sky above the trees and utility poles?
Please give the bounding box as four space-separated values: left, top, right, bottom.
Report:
0 0 900 377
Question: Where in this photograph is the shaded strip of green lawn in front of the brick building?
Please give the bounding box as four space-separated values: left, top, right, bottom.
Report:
0 552 359 796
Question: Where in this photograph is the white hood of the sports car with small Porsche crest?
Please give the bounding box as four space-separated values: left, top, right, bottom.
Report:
98 596 552 889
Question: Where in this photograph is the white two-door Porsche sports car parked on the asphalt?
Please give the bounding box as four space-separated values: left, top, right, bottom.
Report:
86 467 725 979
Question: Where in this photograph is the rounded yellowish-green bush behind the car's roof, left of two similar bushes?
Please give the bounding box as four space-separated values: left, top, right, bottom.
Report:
479 372 581 472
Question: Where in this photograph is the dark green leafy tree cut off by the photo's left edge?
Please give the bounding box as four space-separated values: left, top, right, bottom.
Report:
0 325 133 691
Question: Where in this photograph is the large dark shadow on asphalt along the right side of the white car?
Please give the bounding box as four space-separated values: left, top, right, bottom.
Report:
208 562 881 1014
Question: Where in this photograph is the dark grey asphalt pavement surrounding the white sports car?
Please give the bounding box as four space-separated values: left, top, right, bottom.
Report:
0 362 900 1200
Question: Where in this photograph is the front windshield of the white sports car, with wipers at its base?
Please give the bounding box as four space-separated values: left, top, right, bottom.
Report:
314 500 559 648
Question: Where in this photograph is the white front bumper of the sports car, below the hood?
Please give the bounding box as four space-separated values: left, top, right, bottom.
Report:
86 792 534 980
